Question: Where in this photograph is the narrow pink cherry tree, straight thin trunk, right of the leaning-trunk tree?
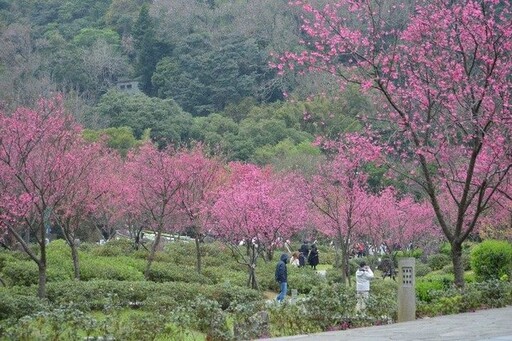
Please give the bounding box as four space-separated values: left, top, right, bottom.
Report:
176 146 224 273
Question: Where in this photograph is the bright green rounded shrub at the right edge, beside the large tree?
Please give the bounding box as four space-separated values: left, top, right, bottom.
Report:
471 239 512 282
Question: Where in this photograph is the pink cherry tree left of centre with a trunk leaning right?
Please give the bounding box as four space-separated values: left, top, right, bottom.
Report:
125 143 185 278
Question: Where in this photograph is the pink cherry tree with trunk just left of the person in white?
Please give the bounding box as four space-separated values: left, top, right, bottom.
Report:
307 134 380 283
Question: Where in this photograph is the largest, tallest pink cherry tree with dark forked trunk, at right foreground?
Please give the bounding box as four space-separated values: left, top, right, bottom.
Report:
277 0 512 287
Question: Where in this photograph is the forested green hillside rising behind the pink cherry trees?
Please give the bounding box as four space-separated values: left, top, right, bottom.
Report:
0 0 369 163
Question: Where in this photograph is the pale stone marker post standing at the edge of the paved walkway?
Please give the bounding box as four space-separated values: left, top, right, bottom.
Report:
398 258 416 322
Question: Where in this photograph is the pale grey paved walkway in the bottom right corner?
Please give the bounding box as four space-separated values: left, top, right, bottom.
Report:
267 306 512 341
